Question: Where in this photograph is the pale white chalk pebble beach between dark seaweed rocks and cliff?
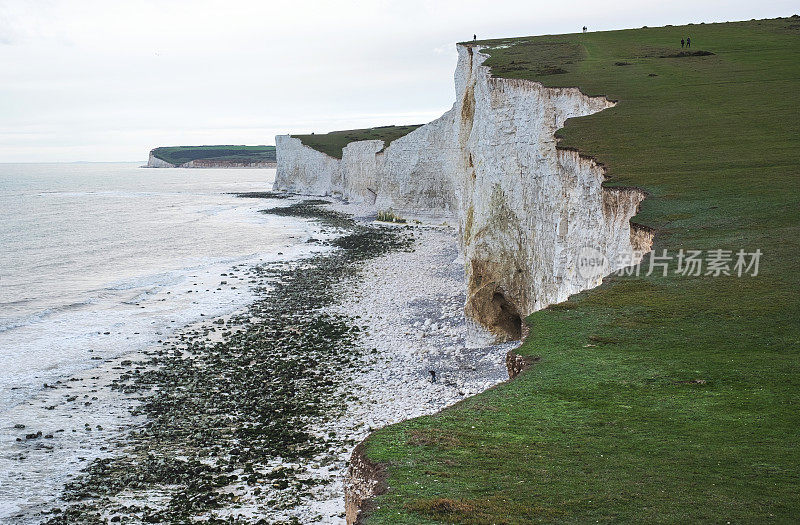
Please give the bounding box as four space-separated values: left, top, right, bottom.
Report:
302 206 518 523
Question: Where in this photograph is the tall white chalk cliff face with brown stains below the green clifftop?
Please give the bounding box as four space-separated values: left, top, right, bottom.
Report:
274 46 652 338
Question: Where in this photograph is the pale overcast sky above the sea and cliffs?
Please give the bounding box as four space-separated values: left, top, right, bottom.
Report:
0 0 797 162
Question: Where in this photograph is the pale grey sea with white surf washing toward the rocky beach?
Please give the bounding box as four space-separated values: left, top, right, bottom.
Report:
0 163 321 523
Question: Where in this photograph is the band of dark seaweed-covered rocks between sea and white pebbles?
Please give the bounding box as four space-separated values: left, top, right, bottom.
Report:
49 200 413 524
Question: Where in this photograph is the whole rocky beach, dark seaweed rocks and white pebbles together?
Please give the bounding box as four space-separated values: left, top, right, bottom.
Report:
23 193 513 524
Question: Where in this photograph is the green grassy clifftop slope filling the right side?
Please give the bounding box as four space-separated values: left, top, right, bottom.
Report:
360 18 800 524
